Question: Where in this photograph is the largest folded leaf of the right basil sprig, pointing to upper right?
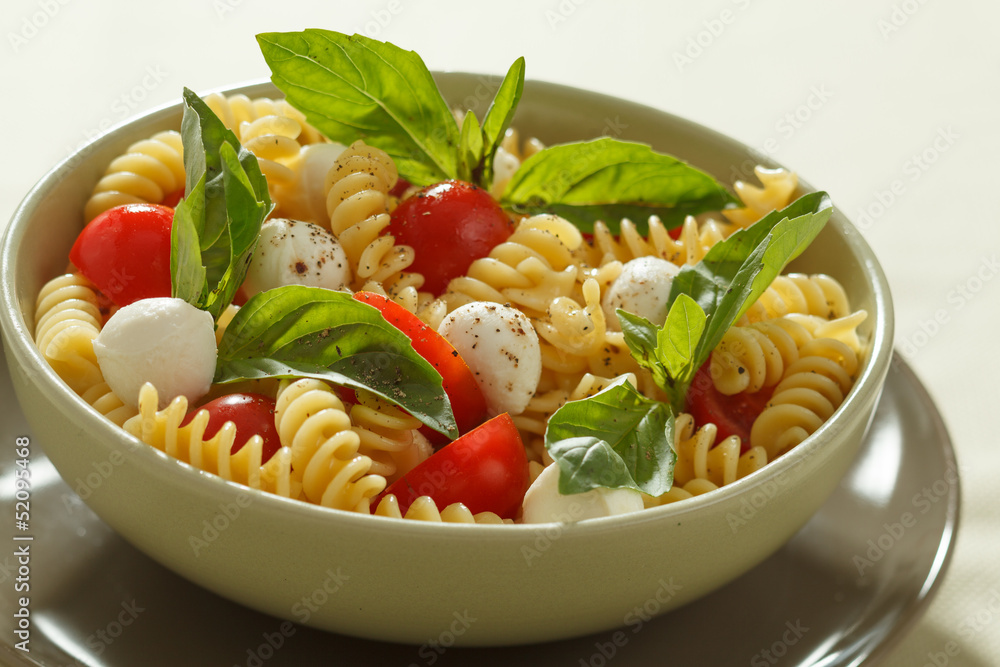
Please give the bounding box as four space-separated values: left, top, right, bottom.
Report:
668 192 833 370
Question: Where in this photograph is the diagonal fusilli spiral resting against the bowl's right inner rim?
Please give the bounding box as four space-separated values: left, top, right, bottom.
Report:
750 338 858 459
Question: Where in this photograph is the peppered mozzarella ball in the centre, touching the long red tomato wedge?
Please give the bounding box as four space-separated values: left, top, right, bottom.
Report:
438 301 542 417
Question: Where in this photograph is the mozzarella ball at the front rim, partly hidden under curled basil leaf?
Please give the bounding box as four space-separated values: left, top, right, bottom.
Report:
522 463 644 523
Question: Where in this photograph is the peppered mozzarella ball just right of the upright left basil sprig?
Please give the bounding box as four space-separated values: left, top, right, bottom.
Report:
243 218 351 296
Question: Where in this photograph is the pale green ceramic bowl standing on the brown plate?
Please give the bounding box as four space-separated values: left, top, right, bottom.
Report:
0 74 892 645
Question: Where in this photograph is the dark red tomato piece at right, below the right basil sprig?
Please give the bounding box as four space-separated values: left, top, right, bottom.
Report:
685 358 774 452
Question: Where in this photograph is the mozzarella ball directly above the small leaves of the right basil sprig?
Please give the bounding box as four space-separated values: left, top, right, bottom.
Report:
601 257 680 331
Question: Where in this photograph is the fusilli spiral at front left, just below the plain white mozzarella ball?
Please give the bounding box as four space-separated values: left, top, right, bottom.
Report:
124 382 292 498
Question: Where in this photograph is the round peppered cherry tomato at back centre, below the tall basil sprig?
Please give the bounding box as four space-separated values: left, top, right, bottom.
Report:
388 181 513 295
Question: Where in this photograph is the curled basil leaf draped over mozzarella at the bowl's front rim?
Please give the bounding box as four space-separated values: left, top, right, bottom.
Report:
545 377 677 496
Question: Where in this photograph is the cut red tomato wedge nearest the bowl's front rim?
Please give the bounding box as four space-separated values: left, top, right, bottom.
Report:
372 412 529 519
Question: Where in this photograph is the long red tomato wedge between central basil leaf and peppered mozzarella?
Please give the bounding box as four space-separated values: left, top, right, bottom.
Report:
354 292 486 444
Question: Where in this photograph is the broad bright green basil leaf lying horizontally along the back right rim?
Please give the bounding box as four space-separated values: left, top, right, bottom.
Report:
500 137 736 234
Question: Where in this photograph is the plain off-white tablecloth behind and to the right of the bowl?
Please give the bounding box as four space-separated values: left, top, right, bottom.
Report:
0 0 1000 667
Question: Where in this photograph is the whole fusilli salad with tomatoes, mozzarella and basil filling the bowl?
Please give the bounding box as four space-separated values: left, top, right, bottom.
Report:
36 30 866 523
